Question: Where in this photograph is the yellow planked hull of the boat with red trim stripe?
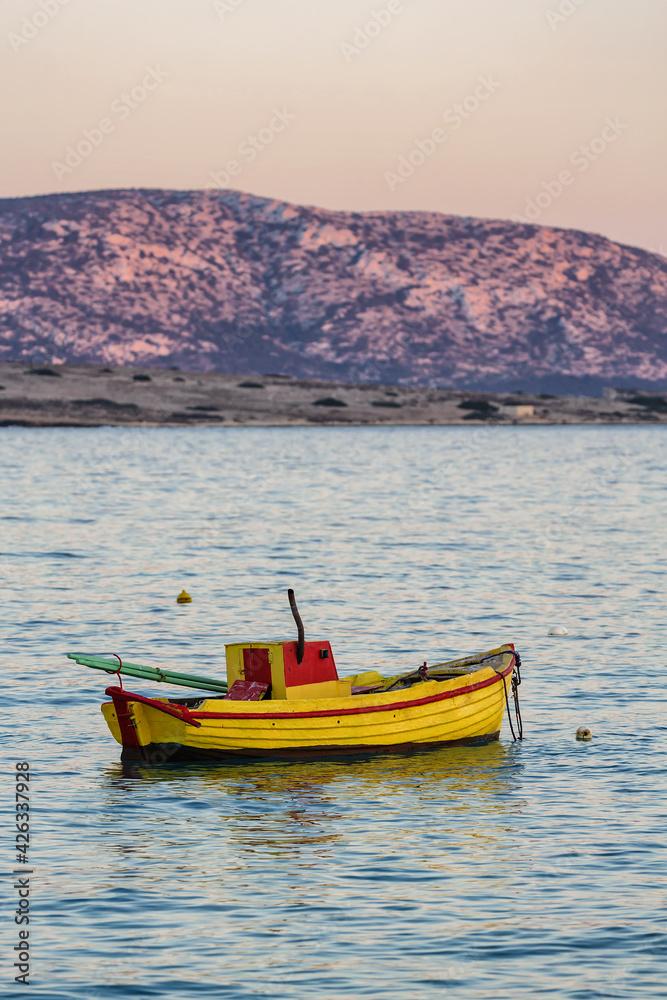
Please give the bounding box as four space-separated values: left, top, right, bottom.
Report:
102 646 515 762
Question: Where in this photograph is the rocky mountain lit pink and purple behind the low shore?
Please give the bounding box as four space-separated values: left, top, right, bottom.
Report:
0 190 667 393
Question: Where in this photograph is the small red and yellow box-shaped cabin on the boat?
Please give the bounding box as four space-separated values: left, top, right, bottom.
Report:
225 641 351 701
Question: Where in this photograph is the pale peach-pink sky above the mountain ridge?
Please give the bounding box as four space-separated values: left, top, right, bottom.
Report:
0 0 667 254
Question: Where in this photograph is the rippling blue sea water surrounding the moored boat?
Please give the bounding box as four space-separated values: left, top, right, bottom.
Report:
0 427 667 1000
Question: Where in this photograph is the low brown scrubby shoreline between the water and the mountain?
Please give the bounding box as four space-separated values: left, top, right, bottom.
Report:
0 361 667 428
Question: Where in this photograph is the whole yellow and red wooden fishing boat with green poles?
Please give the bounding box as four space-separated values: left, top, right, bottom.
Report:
68 591 522 762
